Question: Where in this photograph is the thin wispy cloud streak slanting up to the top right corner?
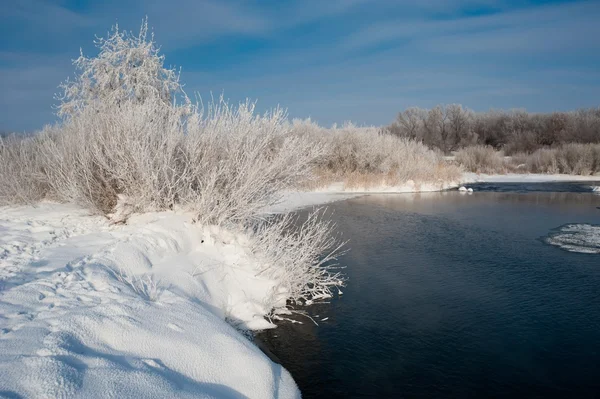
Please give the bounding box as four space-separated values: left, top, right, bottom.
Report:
343 2 600 52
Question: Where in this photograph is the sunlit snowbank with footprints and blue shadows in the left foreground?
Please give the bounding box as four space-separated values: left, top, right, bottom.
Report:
0 203 300 398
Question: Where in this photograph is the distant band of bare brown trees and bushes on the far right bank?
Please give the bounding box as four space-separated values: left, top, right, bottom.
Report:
385 104 600 155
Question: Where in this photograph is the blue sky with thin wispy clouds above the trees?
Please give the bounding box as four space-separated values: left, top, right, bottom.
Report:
0 0 600 131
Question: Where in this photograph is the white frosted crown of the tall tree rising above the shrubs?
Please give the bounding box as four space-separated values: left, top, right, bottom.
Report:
57 20 189 119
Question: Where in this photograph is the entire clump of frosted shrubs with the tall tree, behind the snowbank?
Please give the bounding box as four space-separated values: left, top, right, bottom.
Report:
0 22 324 224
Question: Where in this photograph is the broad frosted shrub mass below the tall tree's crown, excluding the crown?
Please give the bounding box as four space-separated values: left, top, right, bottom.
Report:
37 95 322 224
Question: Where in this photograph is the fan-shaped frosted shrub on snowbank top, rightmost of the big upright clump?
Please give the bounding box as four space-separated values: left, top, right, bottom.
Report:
179 102 324 223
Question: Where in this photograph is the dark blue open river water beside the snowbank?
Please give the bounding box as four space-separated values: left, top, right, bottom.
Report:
261 184 600 398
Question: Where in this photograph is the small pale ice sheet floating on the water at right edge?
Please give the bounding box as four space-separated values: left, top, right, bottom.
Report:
544 223 600 254
